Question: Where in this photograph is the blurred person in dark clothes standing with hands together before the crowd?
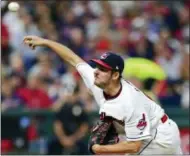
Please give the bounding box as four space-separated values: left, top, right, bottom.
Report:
48 87 88 155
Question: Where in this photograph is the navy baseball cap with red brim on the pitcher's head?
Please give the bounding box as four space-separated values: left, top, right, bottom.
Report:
91 52 124 74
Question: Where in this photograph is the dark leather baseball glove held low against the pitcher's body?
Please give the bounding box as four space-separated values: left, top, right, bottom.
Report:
88 120 119 154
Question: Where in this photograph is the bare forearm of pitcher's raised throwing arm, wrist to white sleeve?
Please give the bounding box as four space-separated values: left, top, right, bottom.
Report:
44 40 84 66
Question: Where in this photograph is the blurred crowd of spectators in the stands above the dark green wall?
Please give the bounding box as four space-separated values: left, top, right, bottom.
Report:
1 0 190 154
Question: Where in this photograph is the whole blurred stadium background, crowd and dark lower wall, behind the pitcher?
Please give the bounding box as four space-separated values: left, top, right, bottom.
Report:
1 0 190 155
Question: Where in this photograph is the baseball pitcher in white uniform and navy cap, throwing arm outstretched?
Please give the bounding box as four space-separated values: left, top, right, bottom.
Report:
24 36 182 155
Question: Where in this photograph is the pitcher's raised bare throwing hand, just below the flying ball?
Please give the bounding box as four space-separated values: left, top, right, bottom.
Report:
23 36 47 49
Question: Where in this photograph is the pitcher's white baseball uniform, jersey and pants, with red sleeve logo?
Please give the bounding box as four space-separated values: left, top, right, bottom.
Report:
76 63 183 154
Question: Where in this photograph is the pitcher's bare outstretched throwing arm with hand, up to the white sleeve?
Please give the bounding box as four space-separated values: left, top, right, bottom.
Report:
24 36 84 66
